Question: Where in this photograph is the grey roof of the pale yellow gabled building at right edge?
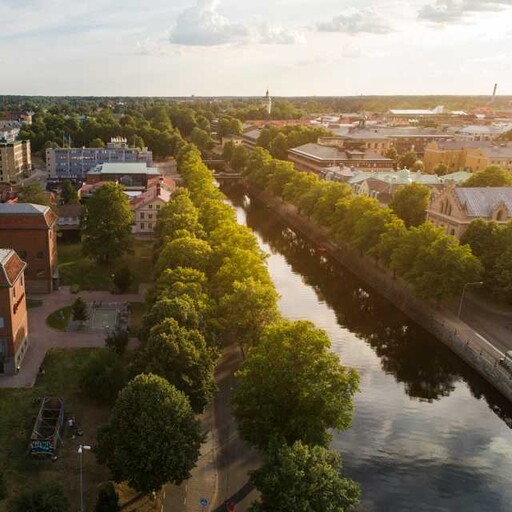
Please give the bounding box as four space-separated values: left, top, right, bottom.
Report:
455 187 512 218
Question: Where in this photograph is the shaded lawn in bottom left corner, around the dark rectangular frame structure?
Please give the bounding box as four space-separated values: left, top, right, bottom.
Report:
0 349 109 512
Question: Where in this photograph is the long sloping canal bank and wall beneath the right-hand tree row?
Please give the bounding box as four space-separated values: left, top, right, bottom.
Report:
246 185 512 402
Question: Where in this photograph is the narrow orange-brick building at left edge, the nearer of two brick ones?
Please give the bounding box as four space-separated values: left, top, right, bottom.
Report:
0 249 28 374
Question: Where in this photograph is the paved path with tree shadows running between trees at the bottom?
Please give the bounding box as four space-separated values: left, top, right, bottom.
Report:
164 345 260 512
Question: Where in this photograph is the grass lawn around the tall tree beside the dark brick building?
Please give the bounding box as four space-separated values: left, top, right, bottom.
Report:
58 240 153 292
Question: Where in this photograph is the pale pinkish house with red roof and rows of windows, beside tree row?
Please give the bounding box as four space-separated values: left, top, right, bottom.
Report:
130 178 176 236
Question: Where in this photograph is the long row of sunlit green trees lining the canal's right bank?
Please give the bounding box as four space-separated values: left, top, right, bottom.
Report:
245 148 482 301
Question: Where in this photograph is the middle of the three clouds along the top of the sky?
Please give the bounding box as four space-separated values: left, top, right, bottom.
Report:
317 8 393 35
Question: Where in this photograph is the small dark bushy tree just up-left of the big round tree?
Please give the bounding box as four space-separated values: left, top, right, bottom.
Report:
80 348 126 404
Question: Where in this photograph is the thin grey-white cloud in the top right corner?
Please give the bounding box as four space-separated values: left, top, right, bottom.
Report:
418 0 512 24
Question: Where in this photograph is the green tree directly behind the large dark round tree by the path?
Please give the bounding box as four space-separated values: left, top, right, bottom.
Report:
136 318 217 413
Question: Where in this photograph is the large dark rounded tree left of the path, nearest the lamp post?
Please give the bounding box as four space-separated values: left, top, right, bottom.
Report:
96 374 204 494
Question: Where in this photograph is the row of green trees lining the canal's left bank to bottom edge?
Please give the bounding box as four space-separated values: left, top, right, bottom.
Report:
174 147 359 512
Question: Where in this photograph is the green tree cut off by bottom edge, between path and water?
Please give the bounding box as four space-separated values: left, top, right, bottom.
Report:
250 441 361 512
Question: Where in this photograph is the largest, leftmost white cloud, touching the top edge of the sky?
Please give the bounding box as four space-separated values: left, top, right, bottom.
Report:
169 0 305 46
